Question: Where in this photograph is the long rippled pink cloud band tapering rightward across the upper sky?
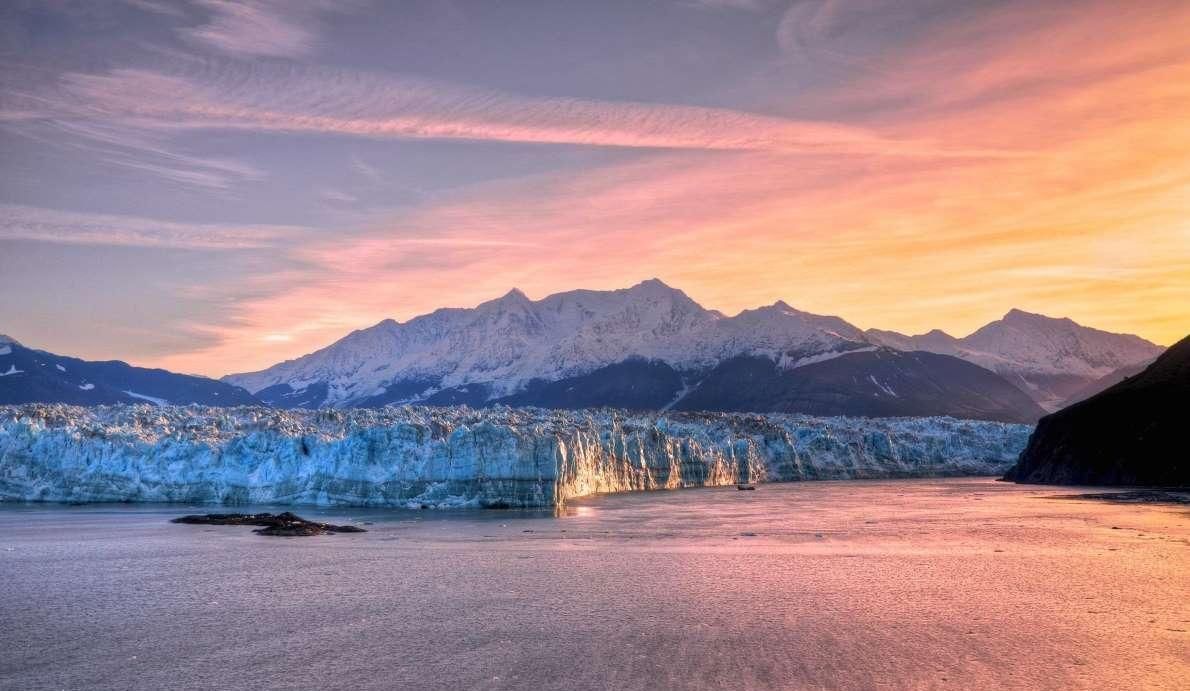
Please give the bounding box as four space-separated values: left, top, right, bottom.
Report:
7 62 1000 157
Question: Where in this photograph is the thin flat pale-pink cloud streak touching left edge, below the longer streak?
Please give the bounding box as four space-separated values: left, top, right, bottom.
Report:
0 205 308 250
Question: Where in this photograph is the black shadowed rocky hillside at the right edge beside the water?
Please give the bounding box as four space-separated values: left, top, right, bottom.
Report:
1004 337 1190 486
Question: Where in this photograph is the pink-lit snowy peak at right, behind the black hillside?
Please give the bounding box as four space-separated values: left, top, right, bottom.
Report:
866 309 1164 410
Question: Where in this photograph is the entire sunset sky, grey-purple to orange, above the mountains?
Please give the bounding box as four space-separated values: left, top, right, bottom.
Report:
0 0 1190 376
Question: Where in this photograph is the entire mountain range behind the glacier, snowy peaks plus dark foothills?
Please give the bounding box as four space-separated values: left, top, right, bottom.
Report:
214 279 1163 422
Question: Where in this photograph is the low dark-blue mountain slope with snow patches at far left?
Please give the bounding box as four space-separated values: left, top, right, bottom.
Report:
0 335 259 406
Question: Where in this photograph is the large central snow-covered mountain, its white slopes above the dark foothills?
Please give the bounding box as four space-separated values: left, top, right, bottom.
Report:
225 279 871 407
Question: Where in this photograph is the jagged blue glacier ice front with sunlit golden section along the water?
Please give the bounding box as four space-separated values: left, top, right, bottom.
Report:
0 404 1031 507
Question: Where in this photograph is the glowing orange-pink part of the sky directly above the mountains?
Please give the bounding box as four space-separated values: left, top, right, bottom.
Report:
143 4 1190 371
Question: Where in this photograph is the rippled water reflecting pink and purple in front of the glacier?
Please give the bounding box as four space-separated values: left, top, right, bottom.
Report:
0 479 1190 690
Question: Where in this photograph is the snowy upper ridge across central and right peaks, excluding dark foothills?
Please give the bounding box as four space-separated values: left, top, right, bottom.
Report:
224 278 1161 415
